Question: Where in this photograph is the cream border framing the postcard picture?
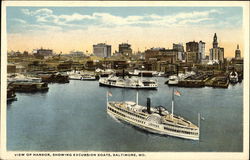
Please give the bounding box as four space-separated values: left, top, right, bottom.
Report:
0 1 250 160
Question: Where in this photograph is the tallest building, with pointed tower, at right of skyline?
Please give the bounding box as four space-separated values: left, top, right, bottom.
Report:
209 33 224 63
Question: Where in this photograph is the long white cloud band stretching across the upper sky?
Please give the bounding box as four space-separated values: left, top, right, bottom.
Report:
19 8 221 27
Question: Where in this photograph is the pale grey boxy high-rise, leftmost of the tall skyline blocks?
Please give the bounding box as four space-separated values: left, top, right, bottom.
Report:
93 43 111 57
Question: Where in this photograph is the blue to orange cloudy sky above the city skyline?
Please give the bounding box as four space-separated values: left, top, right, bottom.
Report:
6 6 243 57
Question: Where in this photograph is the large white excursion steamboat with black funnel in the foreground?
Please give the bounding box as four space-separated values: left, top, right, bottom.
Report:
107 90 200 140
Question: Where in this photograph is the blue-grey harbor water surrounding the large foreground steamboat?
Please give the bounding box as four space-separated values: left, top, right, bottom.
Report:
7 78 243 152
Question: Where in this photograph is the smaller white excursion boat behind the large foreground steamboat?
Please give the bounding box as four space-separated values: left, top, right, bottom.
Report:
99 75 158 89
